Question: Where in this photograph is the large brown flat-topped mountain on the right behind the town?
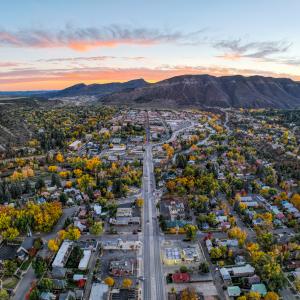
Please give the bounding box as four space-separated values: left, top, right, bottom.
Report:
99 75 300 108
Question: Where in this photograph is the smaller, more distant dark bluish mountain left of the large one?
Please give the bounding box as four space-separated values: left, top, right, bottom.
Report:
47 79 148 97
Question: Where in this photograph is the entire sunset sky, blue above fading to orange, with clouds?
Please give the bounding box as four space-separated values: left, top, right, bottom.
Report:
0 0 300 91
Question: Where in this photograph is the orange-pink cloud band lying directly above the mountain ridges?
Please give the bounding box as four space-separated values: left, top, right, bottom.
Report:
0 65 300 90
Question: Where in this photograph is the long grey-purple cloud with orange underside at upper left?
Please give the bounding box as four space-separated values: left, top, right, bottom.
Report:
0 25 204 51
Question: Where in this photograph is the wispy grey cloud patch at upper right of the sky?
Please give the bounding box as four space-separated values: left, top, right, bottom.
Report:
213 39 292 60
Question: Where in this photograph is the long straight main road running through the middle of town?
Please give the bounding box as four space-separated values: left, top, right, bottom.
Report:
142 112 166 300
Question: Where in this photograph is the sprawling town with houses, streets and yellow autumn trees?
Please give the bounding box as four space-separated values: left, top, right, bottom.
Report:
0 106 300 300
